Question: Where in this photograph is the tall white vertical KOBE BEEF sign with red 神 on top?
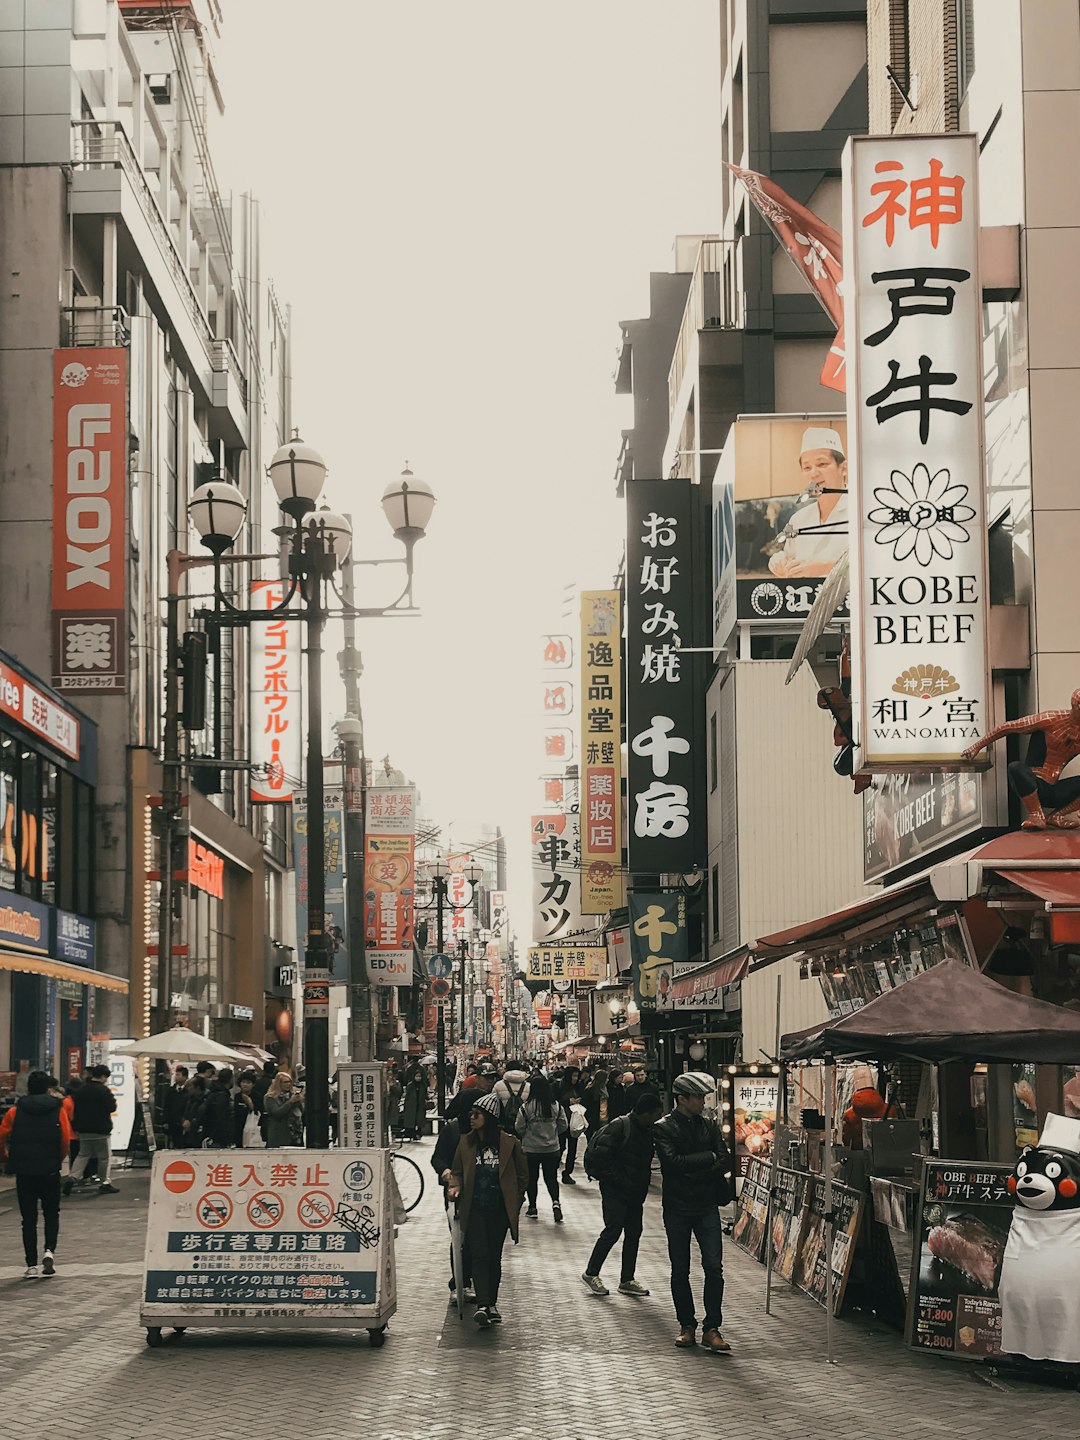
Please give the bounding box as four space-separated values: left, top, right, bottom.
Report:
844 135 991 770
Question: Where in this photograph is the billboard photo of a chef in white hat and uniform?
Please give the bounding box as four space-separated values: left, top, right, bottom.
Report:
726 415 848 621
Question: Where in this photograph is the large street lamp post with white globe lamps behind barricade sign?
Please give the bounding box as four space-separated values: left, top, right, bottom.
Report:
170 435 435 1149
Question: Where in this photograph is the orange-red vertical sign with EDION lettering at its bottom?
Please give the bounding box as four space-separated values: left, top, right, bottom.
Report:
364 785 416 985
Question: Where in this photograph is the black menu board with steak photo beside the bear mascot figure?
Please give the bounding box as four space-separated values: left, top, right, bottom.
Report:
907 1159 1012 1359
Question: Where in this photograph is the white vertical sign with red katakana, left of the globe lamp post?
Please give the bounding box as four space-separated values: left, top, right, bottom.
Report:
251 580 301 805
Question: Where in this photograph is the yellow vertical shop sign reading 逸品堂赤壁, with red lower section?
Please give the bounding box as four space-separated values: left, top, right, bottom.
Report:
580 590 624 914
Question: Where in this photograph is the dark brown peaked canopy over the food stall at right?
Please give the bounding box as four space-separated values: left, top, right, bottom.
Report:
780 960 1080 1066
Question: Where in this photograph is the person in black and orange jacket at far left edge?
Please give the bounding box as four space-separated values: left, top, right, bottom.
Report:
0 1070 73 1280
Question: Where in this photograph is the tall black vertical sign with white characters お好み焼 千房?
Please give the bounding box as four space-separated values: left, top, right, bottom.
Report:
626 480 698 873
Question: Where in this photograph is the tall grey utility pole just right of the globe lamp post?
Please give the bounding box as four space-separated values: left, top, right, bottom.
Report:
334 532 376 1060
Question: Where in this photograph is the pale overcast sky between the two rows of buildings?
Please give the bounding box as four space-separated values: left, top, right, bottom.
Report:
219 0 720 940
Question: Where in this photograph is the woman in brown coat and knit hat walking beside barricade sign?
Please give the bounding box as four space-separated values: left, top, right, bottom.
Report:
448 1094 528 1329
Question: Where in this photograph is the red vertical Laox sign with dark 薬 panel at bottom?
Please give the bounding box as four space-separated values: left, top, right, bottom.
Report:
52 348 128 694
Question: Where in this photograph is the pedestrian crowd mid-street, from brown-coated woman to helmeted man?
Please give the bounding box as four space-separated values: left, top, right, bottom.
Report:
431 1060 733 1355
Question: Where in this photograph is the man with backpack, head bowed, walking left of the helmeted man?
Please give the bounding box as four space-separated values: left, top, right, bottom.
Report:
582 1094 664 1297
